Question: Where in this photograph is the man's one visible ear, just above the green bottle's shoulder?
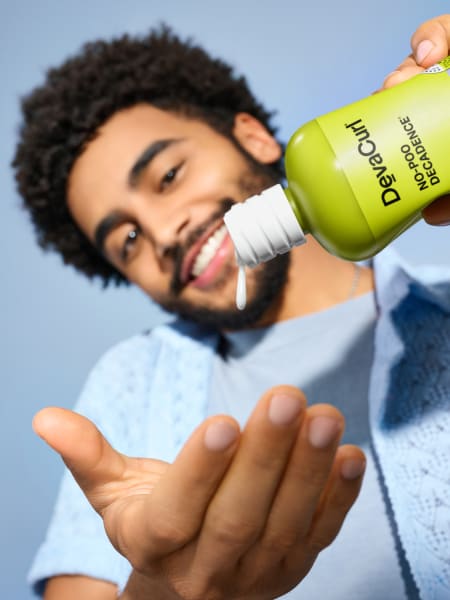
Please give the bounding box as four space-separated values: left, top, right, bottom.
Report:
233 113 281 164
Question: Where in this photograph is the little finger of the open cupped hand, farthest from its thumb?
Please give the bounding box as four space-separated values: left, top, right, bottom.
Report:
308 445 366 553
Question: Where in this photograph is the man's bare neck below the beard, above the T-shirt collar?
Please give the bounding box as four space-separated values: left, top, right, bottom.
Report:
258 236 374 326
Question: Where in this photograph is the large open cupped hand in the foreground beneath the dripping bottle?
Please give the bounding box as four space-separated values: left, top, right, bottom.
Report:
33 386 365 600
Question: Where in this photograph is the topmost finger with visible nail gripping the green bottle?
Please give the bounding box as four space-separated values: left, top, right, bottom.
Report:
411 14 450 68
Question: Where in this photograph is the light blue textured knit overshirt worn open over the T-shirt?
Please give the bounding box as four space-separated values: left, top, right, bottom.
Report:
29 251 450 600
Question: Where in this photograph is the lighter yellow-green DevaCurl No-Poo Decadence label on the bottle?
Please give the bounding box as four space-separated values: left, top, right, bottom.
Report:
317 63 450 239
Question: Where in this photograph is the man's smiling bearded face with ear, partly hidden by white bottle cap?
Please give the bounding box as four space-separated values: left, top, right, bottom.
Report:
68 105 287 328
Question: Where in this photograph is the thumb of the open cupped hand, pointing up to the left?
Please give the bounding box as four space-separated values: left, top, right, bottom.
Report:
33 407 126 512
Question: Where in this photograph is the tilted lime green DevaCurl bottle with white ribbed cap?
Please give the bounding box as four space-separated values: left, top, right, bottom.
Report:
225 57 450 266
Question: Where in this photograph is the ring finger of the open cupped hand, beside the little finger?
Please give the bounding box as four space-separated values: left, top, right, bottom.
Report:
256 405 344 555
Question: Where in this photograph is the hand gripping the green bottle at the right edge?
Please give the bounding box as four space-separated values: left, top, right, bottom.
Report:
383 14 450 225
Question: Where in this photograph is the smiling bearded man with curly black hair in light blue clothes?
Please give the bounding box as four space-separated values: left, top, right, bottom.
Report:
15 15 450 600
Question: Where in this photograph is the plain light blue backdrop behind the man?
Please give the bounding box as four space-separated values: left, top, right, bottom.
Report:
0 0 450 600
